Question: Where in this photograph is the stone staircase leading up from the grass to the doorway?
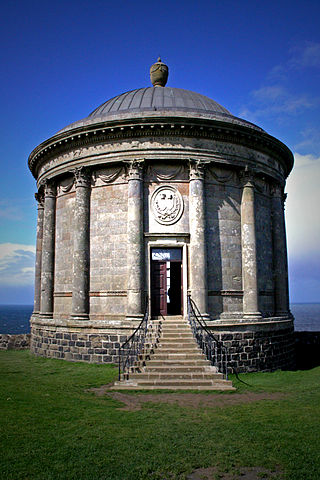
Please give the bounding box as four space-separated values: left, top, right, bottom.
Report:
111 316 235 390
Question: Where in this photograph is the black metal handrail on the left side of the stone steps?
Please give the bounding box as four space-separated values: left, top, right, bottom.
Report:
119 298 149 381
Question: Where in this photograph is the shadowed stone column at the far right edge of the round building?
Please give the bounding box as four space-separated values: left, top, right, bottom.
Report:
271 185 289 316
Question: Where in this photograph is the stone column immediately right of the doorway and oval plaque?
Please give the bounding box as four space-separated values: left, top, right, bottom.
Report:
189 161 209 317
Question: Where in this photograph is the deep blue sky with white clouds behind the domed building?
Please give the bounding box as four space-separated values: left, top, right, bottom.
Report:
0 0 320 304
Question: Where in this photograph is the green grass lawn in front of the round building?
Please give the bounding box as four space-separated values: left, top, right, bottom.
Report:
0 351 320 480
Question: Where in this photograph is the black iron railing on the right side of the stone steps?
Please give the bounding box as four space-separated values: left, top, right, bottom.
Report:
188 295 228 380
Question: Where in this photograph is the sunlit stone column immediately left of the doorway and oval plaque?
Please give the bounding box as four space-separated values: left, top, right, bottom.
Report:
127 161 144 319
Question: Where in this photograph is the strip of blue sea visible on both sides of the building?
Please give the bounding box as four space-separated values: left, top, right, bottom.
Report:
0 303 320 334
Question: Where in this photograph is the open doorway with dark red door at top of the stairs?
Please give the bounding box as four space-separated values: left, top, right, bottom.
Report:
151 248 183 317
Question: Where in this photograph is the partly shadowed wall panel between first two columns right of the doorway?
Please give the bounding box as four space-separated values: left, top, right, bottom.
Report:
206 168 242 318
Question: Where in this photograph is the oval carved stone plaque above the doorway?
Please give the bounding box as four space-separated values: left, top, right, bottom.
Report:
151 186 183 225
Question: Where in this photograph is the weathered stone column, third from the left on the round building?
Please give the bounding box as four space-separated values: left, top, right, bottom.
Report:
71 167 91 320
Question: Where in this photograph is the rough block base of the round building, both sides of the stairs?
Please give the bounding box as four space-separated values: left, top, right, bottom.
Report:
31 320 298 372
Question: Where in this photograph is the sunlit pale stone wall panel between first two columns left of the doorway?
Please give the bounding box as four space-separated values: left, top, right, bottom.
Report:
90 177 128 319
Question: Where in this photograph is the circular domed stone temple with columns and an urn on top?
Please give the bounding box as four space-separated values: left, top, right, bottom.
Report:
29 59 293 371
